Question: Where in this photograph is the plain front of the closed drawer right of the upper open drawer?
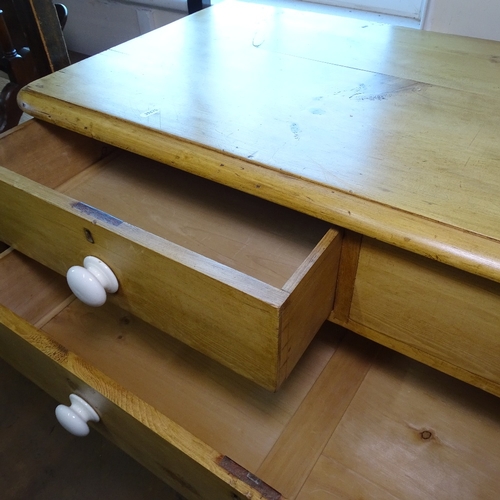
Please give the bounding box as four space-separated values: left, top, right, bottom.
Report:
349 238 500 395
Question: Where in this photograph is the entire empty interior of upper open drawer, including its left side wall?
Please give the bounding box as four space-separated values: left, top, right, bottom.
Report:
0 121 330 288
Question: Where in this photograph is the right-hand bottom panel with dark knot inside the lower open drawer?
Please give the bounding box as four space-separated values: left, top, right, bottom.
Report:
308 351 500 499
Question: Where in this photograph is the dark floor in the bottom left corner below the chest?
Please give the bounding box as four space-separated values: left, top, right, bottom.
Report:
0 359 183 500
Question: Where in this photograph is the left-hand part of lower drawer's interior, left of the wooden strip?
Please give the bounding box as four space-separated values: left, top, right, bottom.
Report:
0 252 343 488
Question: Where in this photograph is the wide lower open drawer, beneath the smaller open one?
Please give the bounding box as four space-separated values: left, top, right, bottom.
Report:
0 251 500 500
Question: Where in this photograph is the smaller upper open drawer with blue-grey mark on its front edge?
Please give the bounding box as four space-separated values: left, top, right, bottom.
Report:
0 120 341 390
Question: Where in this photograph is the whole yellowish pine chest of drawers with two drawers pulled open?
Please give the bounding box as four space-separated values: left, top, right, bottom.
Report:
0 2 500 500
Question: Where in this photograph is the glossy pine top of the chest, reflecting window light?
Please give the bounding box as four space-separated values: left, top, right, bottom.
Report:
20 1 500 281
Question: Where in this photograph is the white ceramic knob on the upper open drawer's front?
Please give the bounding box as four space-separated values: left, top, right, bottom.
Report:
66 257 118 307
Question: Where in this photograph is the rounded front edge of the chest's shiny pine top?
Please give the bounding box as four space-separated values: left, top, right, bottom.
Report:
18 90 500 282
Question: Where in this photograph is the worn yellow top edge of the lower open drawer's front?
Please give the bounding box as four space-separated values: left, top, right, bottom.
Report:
0 304 270 496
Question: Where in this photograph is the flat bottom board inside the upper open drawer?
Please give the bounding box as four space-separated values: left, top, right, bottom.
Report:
58 151 329 288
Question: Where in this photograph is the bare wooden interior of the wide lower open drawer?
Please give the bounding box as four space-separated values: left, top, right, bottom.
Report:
0 252 500 500
